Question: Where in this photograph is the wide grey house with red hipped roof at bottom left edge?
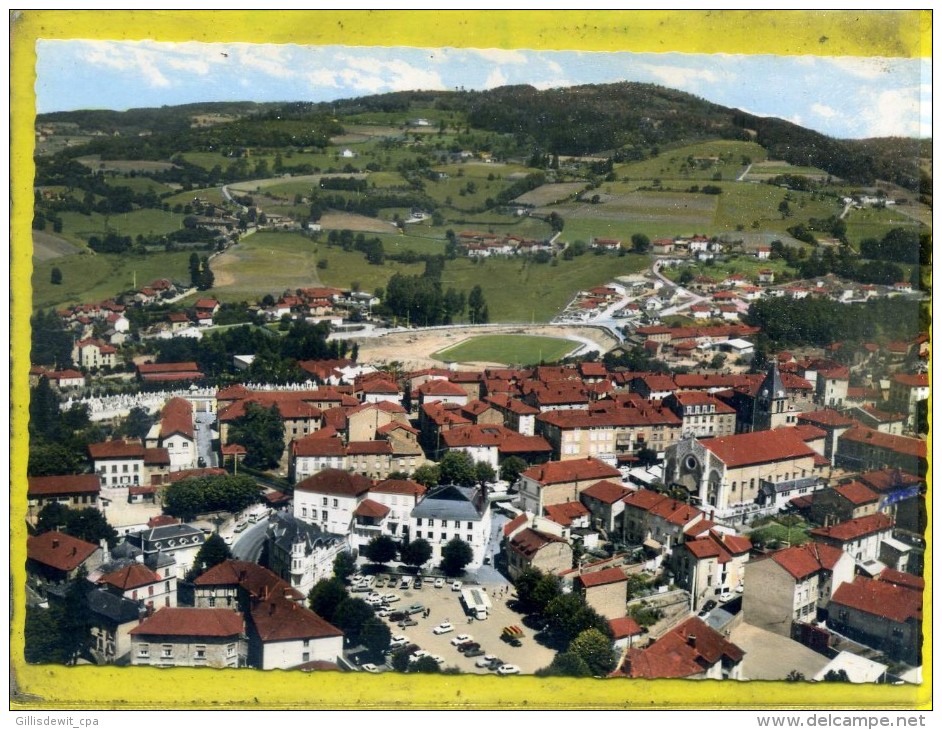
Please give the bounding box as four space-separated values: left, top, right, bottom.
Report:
130 608 248 669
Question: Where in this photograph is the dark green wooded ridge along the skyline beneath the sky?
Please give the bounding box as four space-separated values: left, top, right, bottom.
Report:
37 82 931 195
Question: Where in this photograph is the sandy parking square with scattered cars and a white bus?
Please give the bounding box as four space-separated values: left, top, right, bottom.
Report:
364 580 554 674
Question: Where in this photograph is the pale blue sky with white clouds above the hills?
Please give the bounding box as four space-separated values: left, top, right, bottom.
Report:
36 40 932 138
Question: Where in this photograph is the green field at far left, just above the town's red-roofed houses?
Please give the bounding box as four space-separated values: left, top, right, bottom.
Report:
32 251 197 309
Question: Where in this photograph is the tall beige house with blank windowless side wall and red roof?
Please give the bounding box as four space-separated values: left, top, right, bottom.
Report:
742 542 854 638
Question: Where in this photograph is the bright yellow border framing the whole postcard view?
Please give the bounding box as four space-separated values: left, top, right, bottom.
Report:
10 10 932 709
